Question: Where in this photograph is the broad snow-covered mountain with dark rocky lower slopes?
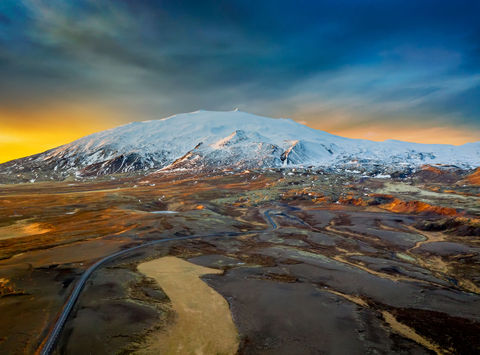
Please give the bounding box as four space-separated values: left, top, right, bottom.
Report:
0 110 480 182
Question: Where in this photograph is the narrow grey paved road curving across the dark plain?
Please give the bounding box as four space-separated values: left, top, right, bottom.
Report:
39 210 278 355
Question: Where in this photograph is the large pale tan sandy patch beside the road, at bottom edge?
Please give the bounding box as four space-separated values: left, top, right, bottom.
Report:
137 256 238 355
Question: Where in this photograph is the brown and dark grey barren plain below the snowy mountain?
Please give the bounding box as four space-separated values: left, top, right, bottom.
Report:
0 167 480 354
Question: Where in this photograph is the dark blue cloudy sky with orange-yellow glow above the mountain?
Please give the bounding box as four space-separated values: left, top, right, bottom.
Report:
0 0 480 162
